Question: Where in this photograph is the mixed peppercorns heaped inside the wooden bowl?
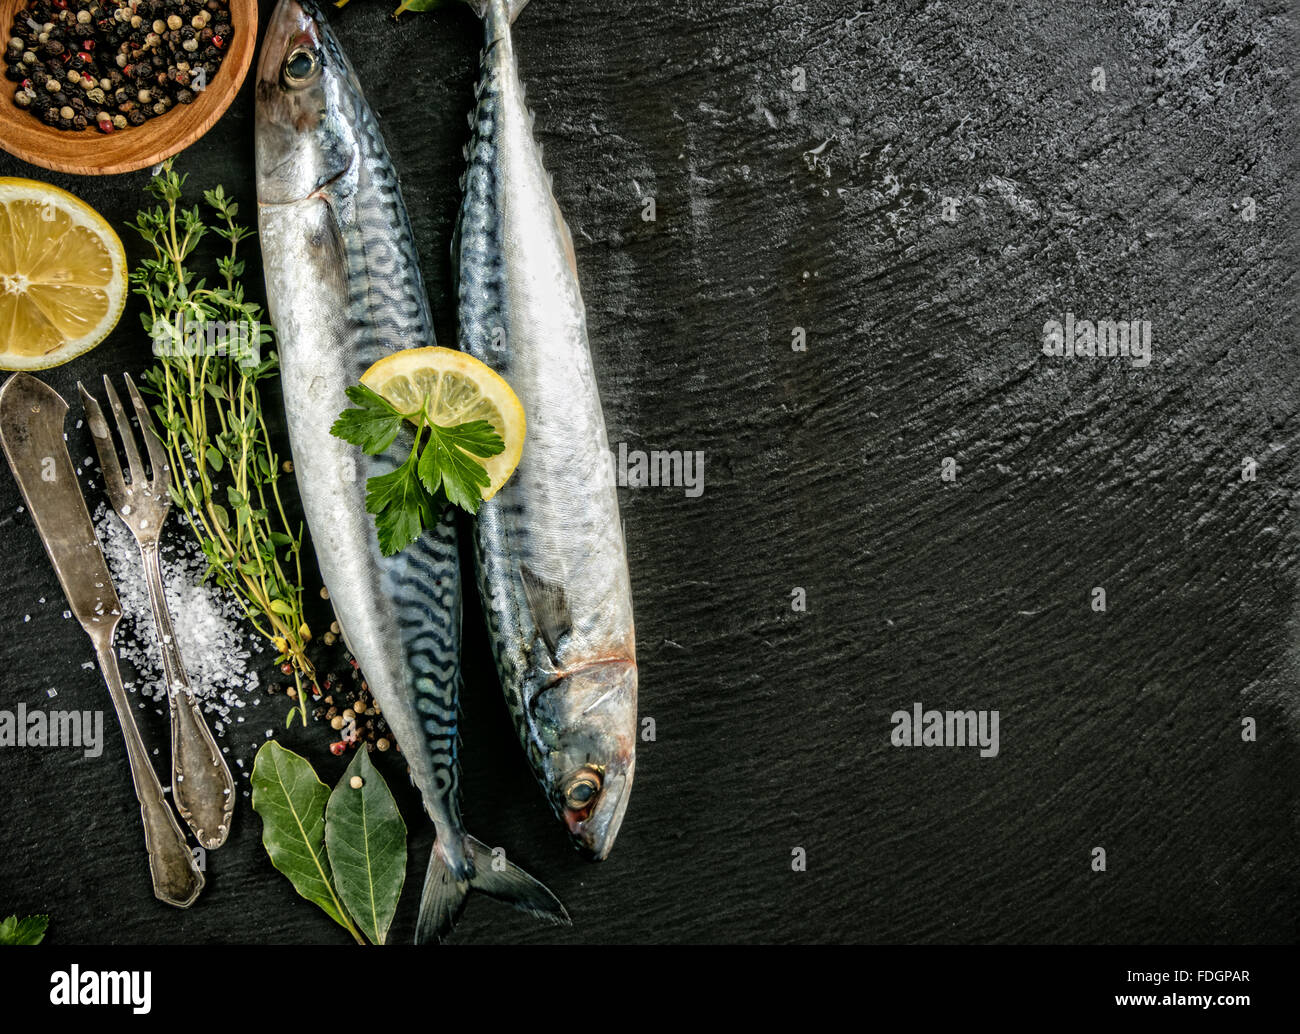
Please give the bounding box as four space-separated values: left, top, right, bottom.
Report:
4 0 234 133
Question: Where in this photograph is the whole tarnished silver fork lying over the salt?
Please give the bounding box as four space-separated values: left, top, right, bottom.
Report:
77 373 235 851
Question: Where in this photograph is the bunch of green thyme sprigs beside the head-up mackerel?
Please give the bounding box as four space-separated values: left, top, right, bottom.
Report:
130 160 316 724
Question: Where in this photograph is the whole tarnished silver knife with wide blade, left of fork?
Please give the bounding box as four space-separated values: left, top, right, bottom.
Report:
0 373 204 908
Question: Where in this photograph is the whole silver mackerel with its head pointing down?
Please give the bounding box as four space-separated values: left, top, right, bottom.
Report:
452 0 637 860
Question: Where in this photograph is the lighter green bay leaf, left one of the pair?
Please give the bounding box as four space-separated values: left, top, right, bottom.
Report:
252 740 360 940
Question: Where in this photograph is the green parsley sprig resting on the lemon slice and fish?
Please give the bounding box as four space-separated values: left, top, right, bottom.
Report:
330 384 506 557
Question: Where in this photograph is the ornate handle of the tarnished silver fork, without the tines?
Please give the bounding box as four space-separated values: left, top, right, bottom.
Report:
140 544 235 851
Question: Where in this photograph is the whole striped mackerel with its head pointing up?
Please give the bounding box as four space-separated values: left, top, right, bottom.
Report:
256 0 568 942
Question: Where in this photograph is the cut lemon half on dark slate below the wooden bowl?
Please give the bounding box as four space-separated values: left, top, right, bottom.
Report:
0 177 126 369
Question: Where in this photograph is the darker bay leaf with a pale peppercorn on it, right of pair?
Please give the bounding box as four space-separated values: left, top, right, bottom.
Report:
325 749 406 944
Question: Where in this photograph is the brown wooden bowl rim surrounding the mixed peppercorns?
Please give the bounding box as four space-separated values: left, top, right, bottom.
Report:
0 0 257 176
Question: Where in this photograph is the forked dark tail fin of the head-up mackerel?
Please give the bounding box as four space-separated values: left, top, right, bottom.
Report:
415 834 572 944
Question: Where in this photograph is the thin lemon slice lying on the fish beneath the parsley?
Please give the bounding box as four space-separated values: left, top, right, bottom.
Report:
361 349 527 499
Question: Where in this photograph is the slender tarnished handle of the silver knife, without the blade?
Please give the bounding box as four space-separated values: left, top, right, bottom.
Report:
95 636 204 908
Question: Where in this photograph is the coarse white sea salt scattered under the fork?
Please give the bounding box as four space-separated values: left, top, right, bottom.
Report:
95 503 257 735
